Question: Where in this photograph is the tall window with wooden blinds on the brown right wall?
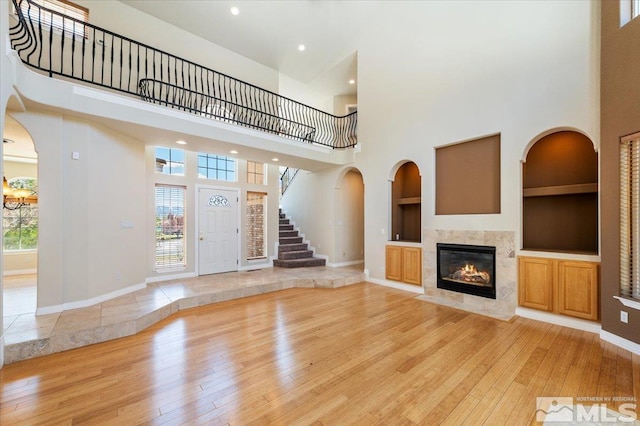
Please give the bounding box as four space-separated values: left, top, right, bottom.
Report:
620 135 640 299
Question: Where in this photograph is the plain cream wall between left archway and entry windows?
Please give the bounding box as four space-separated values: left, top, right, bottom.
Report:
7 110 146 308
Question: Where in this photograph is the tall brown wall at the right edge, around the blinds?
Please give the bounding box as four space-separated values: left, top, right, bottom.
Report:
600 1 640 343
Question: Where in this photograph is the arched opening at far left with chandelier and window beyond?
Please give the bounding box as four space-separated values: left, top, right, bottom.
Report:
2 114 38 326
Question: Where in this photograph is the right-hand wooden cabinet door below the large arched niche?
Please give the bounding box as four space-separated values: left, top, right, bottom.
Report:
558 261 598 321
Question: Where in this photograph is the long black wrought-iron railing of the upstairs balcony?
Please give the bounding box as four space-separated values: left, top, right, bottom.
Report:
10 0 358 148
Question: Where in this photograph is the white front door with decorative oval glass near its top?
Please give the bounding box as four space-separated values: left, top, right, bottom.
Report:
198 188 238 275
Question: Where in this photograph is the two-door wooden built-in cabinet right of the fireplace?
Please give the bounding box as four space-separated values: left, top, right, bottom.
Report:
518 257 599 321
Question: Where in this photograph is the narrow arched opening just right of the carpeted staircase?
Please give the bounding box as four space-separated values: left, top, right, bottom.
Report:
334 168 364 265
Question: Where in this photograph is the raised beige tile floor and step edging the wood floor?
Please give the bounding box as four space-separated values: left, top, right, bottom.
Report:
3 265 365 363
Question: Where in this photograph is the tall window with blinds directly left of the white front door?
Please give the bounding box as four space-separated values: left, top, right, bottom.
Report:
155 185 186 270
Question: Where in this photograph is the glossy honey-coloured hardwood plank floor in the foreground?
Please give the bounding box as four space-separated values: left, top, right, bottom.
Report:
0 284 640 425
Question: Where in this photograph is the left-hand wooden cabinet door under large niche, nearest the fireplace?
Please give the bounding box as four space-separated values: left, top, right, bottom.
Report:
518 257 553 312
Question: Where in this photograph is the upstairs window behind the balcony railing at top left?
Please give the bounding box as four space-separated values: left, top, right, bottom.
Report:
20 0 89 37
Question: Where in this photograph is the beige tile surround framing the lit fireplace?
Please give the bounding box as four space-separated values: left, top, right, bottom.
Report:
419 230 518 320
